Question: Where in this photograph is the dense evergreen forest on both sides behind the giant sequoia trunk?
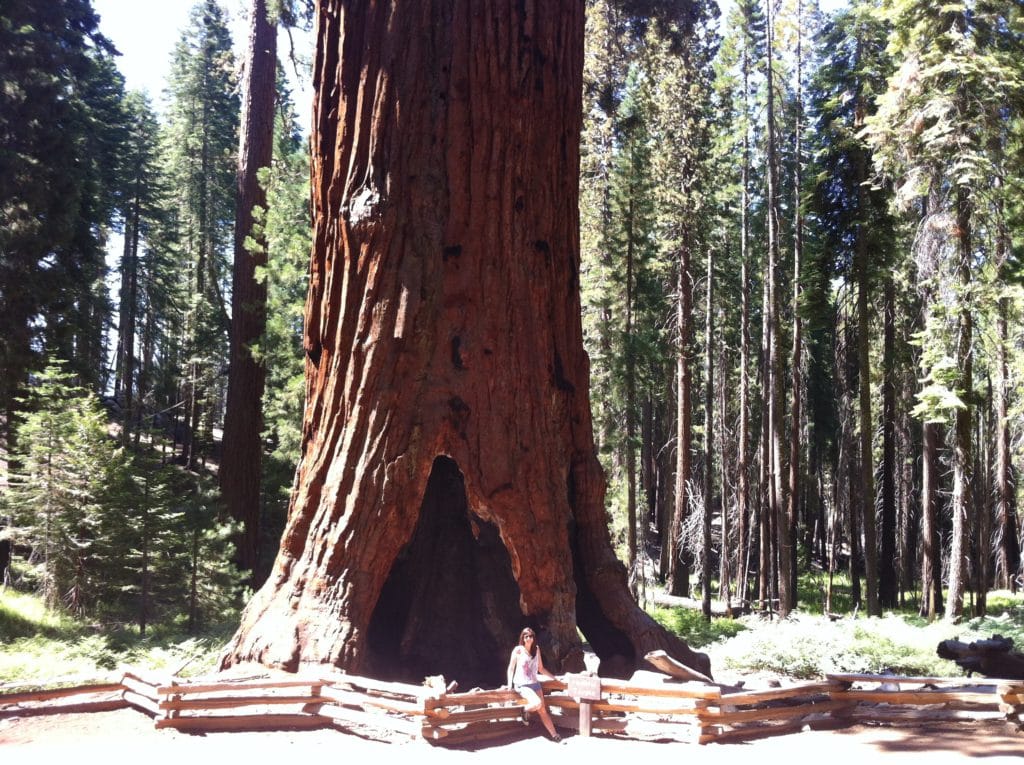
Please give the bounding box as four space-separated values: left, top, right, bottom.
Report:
6 0 1024 647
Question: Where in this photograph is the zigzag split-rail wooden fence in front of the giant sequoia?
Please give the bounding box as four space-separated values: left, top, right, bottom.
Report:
0 672 1024 745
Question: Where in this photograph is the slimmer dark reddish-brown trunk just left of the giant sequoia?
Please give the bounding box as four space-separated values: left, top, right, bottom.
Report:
220 0 278 584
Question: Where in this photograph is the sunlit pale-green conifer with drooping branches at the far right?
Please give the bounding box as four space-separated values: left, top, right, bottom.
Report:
869 0 1022 619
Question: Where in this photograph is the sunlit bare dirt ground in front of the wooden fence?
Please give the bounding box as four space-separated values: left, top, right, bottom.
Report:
0 709 1024 765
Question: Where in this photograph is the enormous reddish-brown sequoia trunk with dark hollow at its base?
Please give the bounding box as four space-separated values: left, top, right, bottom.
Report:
223 0 709 683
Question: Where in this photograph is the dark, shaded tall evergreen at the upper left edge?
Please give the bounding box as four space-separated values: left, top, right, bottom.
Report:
0 0 123 448
